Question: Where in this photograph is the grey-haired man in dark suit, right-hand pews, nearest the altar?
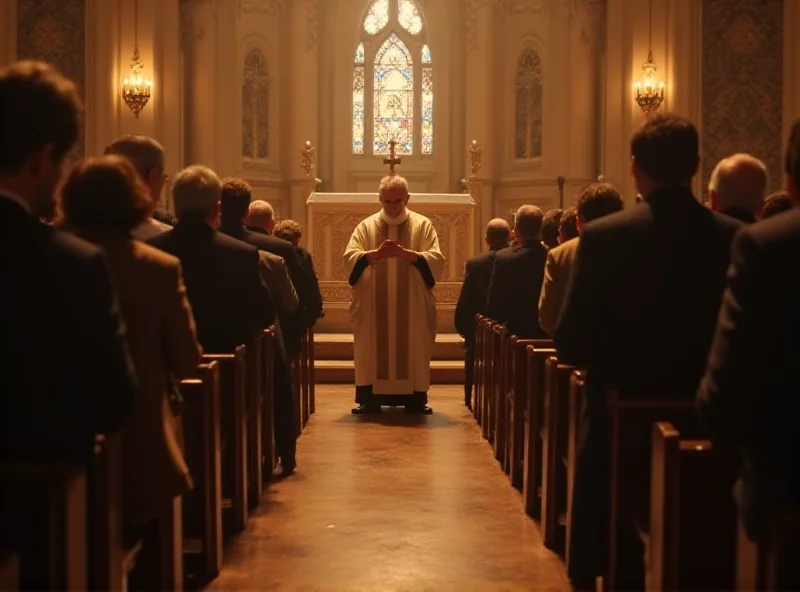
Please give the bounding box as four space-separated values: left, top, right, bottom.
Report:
455 218 511 409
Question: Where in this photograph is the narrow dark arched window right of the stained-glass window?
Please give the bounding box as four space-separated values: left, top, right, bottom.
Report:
514 49 542 159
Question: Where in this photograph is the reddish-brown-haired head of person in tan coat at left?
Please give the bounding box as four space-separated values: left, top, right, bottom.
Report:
60 154 150 236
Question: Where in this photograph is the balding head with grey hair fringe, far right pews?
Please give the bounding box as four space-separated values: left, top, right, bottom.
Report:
708 154 769 218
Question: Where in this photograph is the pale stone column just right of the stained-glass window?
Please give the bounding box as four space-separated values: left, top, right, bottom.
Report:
462 0 494 252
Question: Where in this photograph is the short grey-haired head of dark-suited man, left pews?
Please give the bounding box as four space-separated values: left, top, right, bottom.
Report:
172 164 222 227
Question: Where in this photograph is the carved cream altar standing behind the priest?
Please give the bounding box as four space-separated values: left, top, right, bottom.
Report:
304 192 476 333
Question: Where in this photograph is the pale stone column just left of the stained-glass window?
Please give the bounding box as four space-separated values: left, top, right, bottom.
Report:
288 0 319 227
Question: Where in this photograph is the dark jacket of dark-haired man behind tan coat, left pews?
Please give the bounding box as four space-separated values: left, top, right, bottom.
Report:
219 224 318 358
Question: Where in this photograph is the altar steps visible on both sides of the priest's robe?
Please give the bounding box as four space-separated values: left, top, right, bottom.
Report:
314 333 464 384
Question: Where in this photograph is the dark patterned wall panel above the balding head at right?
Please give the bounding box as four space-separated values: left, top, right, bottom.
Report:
702 0 784 199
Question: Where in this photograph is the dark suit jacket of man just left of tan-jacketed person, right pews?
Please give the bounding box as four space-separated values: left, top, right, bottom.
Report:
486 239 549 339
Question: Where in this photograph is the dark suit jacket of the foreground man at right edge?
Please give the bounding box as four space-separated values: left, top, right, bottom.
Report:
698 211 800 539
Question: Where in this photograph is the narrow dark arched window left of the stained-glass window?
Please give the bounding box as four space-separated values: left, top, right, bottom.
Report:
242 49 269 160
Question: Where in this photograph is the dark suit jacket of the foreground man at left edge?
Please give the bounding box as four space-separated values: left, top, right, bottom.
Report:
0 195 137 459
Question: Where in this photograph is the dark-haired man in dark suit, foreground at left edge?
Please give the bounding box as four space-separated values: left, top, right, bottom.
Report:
0 62 136 461
